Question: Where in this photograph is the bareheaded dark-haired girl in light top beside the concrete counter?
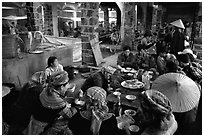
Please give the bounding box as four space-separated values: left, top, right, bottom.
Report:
45 56 64 80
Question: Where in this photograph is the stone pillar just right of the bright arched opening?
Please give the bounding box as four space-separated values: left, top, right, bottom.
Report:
121 2 135 48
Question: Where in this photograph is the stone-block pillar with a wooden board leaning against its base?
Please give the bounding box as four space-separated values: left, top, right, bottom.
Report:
80 2 99 66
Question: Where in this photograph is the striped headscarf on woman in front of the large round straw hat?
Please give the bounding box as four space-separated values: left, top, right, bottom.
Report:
141 90 172 115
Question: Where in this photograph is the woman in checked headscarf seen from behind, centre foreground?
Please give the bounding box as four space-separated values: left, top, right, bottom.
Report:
69 86 118 135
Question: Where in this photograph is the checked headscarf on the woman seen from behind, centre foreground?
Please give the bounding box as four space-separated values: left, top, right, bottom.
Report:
87 86 107 104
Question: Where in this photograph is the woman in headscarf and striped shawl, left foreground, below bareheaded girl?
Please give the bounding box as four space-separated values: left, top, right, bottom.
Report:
24 71 77 135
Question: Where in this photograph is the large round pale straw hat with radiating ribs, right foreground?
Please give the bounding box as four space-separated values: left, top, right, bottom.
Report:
152 73 200 112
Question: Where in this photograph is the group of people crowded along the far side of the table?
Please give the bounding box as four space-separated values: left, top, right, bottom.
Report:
117 18 202 83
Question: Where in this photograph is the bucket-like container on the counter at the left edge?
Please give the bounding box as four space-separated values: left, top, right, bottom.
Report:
2 35 18 59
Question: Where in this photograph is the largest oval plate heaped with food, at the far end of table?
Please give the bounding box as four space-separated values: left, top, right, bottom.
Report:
121 79 144 89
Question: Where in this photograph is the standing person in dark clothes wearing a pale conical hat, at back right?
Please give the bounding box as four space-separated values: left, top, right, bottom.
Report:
170 19 185 56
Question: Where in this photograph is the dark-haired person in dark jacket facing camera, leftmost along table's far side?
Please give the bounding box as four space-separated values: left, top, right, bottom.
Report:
117 46 135 69
